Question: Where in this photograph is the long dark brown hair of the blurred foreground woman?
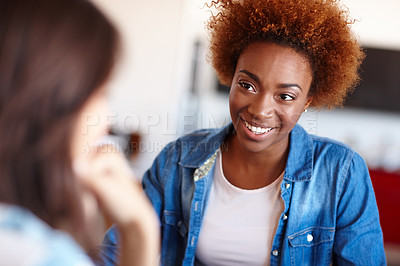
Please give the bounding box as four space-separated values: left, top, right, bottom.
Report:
0 0 118 242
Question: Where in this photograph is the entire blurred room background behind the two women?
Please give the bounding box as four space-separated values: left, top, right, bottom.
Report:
93 0 400 265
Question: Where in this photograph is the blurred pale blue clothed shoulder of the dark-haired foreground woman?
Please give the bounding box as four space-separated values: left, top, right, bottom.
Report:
0 204 93 265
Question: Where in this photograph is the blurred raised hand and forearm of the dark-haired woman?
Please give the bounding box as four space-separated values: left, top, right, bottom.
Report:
74 145 160 265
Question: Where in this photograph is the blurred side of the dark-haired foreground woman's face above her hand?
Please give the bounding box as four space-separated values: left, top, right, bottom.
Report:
72 88 109 161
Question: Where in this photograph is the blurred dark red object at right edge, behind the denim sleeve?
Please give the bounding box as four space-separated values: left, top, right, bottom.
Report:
369 169 400 244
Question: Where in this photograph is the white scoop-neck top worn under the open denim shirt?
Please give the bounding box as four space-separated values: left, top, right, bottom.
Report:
196 151 284 266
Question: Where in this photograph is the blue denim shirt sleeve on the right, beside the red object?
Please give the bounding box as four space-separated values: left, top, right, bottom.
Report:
333 153 386 265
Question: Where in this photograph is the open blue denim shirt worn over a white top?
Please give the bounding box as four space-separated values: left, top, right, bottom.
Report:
103 124 386 265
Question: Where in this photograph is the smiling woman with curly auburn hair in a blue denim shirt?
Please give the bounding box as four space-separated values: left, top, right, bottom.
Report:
101 0 385 266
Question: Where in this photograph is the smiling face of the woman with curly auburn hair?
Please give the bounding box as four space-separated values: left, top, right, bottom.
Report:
229 43 312 152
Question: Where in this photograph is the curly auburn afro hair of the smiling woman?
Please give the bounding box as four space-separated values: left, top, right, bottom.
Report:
208 0 365 108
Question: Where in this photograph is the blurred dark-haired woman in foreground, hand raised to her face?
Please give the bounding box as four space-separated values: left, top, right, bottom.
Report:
0 0 159 265
